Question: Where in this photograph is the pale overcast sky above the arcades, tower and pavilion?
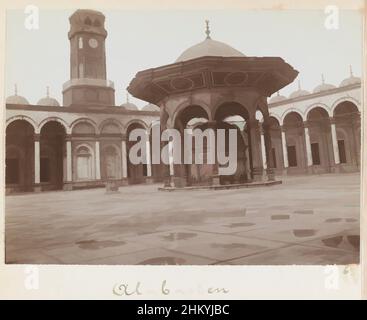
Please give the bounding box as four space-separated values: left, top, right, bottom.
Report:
5 8 362 108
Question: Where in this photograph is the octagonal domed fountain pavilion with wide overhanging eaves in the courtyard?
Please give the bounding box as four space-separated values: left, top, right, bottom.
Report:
128 21 298 189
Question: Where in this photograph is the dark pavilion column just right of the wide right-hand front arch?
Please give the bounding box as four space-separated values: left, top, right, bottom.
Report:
247 120 263 181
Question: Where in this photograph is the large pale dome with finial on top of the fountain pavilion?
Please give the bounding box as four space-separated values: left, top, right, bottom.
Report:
175 20 245 62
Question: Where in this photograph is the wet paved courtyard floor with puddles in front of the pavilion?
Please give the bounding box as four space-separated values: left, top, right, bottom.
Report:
5 174 359 265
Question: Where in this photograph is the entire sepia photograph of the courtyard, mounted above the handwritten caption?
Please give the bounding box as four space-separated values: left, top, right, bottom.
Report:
3 5 363 272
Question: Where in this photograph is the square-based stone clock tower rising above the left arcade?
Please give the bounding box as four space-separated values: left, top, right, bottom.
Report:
63 10 115 106
